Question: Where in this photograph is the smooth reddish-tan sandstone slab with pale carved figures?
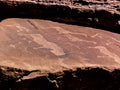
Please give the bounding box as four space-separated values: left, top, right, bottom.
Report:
0 18 120 71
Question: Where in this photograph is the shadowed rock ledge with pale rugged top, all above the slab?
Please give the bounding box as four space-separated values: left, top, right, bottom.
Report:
0 0 120 32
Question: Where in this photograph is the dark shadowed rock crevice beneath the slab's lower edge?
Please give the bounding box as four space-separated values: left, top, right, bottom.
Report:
0 67 120 90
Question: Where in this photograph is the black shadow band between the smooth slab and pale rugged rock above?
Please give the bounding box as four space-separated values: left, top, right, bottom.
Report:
0 2 120 33
